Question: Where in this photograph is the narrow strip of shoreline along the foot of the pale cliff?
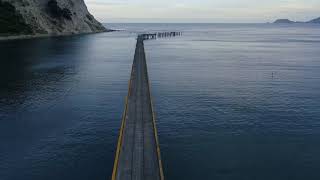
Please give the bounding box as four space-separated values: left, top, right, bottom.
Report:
0 29 117 42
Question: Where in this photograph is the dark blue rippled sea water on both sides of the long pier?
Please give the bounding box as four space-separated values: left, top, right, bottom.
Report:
0 24 320 180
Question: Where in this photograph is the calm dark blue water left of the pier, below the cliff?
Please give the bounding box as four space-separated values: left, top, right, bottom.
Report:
0 34 134 179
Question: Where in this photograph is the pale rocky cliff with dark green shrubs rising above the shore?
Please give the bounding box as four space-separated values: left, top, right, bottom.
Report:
0 0 106 35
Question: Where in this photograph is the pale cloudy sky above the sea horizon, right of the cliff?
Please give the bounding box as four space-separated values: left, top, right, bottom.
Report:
85 0 320 23
